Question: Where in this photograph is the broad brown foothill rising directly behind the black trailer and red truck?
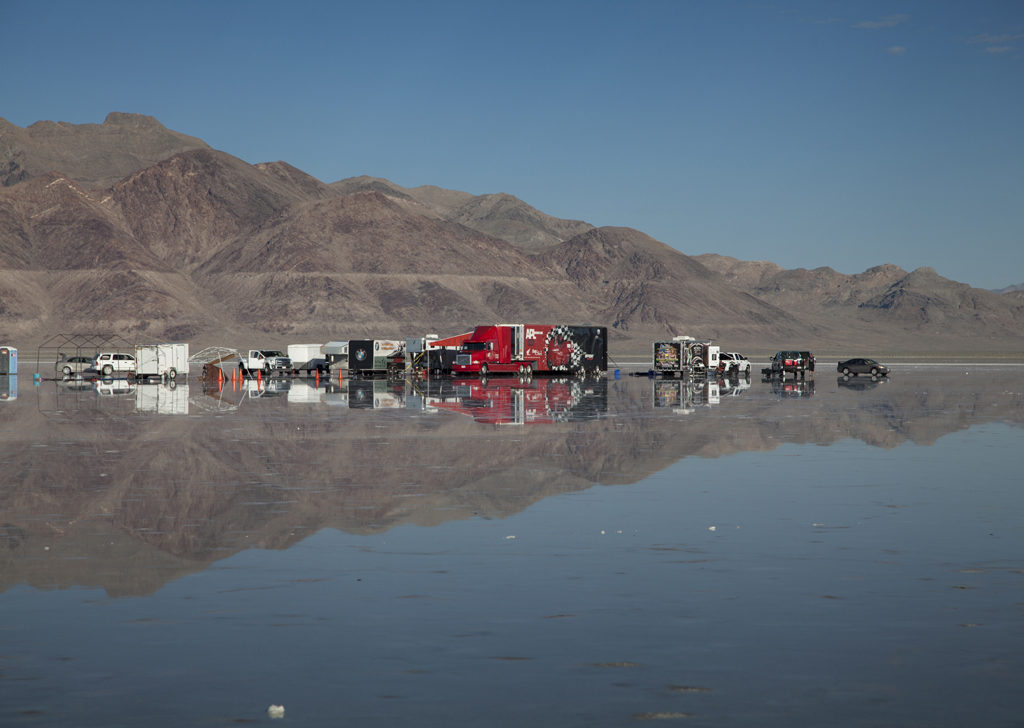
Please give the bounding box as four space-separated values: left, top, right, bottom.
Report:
197 191 593 338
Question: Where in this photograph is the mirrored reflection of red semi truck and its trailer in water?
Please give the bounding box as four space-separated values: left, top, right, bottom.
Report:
427 377 608 425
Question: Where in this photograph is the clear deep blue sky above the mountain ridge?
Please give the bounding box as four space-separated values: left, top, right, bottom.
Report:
0 0 1024 288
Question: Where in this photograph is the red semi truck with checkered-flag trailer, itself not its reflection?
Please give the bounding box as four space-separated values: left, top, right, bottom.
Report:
452 324 608 377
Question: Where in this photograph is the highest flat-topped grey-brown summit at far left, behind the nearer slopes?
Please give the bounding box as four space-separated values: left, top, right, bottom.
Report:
0 112 209 188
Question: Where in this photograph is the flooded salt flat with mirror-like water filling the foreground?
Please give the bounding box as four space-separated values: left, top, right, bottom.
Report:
0 365 1024 726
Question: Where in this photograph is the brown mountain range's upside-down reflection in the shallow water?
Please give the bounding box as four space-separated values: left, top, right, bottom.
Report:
0 368 1024 595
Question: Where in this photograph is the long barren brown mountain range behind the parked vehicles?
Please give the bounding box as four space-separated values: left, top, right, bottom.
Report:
0 113 1024 355
